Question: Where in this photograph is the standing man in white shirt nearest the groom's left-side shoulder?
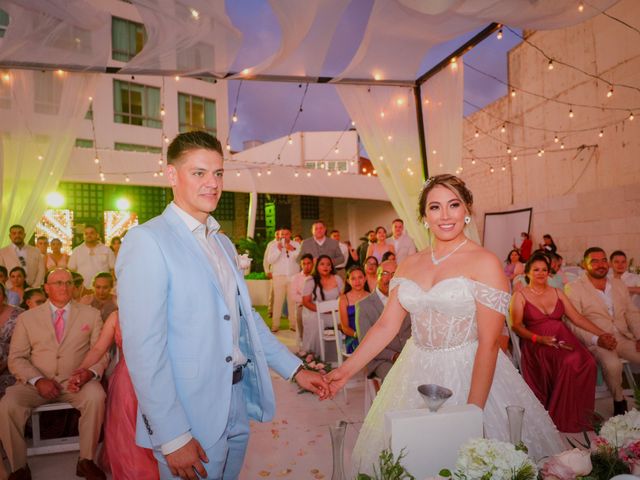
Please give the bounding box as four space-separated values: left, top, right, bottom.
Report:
69 225 116 288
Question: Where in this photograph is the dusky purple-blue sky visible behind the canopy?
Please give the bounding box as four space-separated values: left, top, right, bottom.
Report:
226 0 520 151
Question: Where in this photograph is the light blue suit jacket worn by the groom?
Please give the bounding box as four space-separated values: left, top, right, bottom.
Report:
116 207 300 449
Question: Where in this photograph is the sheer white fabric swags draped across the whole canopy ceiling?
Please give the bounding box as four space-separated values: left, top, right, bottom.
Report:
0 0 617 82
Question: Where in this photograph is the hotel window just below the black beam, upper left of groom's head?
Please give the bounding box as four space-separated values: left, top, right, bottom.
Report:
113 80 162 128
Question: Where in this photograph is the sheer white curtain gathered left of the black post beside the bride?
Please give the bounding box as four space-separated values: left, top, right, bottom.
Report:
336 85 428 248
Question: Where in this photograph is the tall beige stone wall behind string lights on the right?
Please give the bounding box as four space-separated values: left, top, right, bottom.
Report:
461 0 640 263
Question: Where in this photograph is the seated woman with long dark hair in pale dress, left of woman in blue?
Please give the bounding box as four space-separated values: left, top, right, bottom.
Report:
302 255 344 353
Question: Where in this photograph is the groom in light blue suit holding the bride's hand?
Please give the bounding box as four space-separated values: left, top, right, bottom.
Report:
116 132 328 479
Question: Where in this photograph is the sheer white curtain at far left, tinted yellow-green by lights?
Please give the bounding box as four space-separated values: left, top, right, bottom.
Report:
0 70 97 244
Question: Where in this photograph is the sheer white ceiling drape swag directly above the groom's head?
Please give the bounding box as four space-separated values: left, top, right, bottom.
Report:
121 0 242 76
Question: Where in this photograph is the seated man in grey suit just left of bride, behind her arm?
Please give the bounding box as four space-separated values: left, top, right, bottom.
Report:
356 261 411 380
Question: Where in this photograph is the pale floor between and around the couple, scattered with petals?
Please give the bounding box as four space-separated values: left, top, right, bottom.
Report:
1 331 631 480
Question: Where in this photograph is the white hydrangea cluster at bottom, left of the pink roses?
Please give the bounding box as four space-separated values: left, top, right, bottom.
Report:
440 438 537 480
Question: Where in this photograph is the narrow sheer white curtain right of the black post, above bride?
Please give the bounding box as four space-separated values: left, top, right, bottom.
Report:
422 59 464 176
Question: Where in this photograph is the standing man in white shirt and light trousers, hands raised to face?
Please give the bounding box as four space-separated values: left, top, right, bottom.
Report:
265 228 300 332
